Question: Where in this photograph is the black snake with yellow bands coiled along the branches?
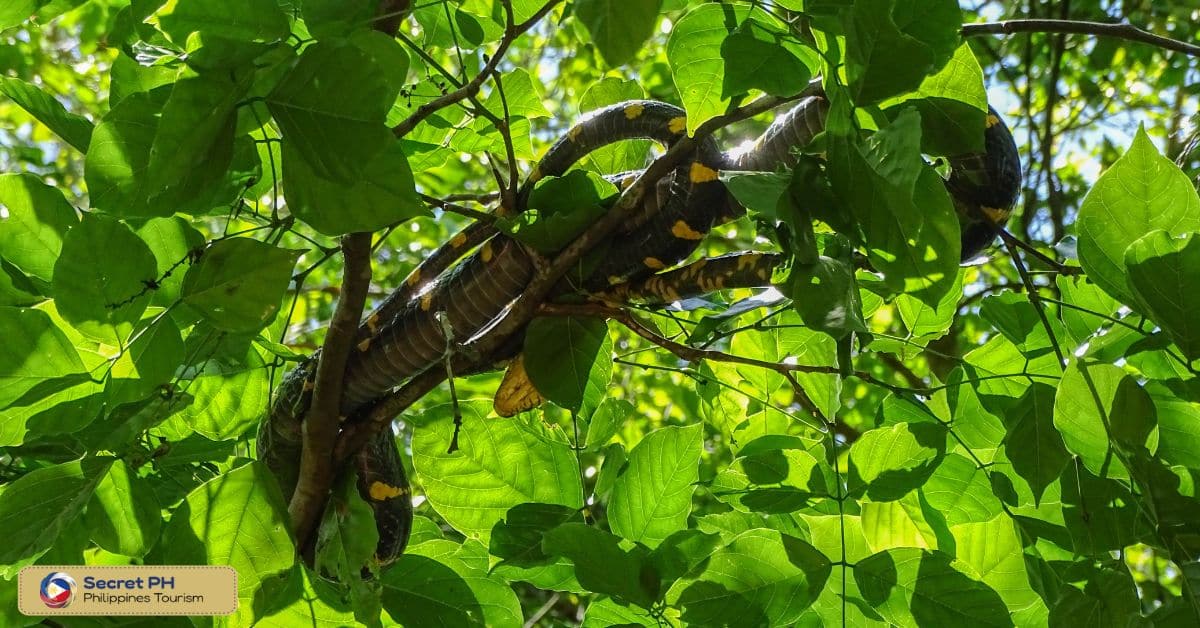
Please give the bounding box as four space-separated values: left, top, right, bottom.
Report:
258 84 1021 568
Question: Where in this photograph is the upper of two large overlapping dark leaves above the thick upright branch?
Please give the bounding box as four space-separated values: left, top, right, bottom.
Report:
266 42 398 183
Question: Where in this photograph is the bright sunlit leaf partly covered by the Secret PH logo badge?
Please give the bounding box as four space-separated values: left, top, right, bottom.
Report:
162 462 295 608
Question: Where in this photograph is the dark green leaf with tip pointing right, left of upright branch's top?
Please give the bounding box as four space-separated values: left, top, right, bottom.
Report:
182 238 300 333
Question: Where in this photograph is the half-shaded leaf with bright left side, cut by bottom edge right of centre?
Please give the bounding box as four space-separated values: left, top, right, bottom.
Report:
854 548 1013 627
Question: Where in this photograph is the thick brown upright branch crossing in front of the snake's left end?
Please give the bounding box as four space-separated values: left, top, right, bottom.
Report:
288 233 371 548
